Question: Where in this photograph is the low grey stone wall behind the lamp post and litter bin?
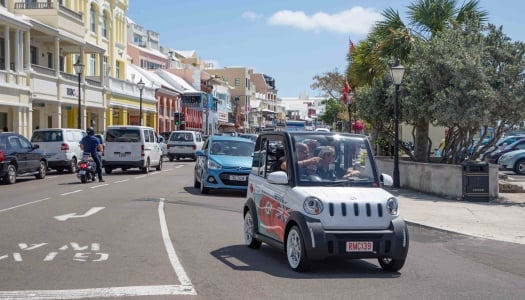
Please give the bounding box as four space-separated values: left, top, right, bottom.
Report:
376 156 499 200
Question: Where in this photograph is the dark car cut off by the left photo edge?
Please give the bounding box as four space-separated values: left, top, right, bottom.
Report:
0 132 47 184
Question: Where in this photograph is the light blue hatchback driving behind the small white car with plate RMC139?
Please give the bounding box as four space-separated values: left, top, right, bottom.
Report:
193 135 255 194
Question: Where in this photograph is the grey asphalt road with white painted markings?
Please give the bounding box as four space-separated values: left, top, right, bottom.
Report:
0 161 525 299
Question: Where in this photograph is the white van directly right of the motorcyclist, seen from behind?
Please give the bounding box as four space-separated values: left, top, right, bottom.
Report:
102 125 162 174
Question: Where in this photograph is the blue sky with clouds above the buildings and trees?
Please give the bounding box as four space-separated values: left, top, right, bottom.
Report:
128 0 525 97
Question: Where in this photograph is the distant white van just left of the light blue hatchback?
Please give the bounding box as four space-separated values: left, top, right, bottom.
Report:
168 130 204 161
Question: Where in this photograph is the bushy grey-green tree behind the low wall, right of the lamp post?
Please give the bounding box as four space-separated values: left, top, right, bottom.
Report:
403 21 525 164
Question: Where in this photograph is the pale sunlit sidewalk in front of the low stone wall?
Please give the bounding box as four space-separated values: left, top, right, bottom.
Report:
385 188 525 245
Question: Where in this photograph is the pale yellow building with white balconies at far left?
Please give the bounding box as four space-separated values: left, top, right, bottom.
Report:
0 0 156 136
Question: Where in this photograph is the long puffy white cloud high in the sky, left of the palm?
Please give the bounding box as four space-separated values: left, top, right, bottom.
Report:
268 6 382 34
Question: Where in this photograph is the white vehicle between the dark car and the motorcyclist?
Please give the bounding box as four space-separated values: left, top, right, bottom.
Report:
31 128 87 173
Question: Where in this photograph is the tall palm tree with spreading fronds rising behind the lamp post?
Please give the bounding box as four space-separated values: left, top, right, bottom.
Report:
348 0 488 161
